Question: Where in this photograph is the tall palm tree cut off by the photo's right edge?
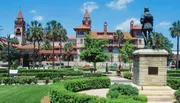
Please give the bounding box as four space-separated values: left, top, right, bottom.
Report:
169 21 180 68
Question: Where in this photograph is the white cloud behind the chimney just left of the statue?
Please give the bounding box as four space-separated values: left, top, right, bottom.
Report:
116 18 140 31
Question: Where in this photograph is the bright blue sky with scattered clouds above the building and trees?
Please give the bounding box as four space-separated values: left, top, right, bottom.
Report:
0 0 180 49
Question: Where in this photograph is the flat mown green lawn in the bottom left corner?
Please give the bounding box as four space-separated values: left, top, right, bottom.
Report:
0 85 49 103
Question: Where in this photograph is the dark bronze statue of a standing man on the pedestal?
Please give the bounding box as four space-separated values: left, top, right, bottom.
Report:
140 7 155 49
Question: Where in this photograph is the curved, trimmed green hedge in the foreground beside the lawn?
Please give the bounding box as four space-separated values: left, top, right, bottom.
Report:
50 77 145 103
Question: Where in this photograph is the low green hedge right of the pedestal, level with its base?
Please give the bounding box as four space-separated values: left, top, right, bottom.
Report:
167 78 180 90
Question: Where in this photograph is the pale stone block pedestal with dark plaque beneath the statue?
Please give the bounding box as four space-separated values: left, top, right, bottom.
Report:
133 49 168 86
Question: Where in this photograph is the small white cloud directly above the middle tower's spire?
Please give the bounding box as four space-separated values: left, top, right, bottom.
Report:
81 2 98 13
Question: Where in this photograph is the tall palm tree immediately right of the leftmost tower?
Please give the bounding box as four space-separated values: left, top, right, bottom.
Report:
27 21 43 68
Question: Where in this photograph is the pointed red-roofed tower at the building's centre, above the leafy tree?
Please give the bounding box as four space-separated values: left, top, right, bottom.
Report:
82 9 91 27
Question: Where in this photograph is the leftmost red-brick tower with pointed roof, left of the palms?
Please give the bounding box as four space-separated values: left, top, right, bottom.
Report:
14 10 26 44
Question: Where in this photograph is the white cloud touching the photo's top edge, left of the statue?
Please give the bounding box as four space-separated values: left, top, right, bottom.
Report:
106 0 134 10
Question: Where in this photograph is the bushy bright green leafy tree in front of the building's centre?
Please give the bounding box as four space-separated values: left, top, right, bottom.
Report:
79 34 108 69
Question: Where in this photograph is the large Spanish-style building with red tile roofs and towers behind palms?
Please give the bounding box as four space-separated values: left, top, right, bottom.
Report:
9 10 144 66
